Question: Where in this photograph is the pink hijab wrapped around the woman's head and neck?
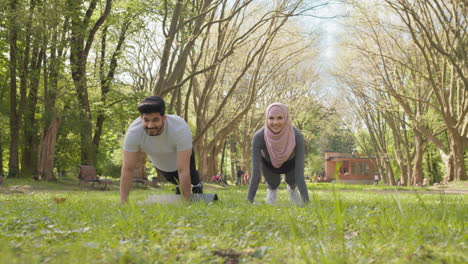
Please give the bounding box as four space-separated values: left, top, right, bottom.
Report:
264 103 296 168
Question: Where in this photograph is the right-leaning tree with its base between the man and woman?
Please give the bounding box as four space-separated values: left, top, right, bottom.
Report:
189 1 324 178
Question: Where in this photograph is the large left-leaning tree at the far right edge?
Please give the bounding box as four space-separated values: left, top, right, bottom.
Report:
386 0 468 180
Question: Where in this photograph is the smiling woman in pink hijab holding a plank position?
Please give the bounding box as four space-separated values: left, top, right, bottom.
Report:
247 103 309 205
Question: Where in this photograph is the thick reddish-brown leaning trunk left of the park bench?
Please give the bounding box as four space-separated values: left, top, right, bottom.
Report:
37 117 60 181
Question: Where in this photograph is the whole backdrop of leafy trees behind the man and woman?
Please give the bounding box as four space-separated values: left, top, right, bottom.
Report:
0 0 468 185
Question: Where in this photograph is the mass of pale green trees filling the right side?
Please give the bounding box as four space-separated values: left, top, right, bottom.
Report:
337 0 468 184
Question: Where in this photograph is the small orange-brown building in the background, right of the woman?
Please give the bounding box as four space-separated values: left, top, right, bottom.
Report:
324 152 376 184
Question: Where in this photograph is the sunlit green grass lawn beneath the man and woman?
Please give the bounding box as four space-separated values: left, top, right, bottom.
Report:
0 180 468 263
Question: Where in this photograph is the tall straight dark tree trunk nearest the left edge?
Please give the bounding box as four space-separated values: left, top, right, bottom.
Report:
8 0 20 177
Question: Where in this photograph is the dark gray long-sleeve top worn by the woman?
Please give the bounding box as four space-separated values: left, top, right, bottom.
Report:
247 128 309 203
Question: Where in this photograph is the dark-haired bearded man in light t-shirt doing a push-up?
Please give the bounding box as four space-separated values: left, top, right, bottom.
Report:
120 96 203 203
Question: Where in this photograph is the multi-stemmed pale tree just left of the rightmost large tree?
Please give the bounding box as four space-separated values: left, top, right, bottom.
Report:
338 1 466 184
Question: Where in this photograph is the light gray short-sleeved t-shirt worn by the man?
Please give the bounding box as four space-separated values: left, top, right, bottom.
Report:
124 115 192 172
